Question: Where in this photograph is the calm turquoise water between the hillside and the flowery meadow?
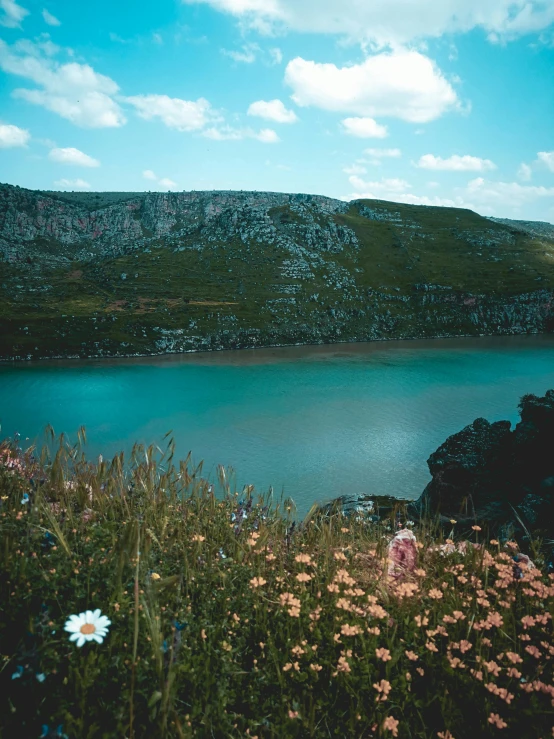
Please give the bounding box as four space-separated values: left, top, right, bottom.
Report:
0 336 554 515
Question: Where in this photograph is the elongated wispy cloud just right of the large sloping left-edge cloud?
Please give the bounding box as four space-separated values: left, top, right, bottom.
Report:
125 95 214 131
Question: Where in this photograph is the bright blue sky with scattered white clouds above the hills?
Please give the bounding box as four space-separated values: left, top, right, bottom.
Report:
0 0 554 222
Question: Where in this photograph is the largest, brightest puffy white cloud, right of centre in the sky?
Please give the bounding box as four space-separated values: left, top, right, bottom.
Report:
285 50 461 123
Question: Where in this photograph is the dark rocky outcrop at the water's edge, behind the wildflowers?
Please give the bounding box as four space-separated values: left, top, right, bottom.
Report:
320 390 554 570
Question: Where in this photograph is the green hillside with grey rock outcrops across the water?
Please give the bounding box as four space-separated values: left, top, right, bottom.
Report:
0 185 554 359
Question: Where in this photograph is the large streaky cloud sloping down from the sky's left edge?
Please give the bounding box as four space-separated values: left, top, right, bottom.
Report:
0 40 126 128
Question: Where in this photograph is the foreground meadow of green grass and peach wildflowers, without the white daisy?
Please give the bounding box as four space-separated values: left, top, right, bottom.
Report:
0 431 554 739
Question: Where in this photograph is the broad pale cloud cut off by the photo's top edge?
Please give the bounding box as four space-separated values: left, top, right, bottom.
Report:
182 0 554 46
